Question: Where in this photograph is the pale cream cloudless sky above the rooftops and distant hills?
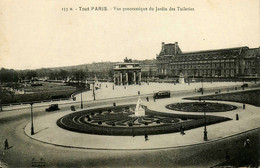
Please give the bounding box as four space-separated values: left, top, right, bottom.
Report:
0 0 260 69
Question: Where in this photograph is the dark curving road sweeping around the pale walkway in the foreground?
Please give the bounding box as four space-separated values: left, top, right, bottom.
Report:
0 86 260 167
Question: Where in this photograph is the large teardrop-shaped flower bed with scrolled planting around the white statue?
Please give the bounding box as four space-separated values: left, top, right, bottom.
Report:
57 105 230 136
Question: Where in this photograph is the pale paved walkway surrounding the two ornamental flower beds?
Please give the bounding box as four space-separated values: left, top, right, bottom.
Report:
24 98 258 150
